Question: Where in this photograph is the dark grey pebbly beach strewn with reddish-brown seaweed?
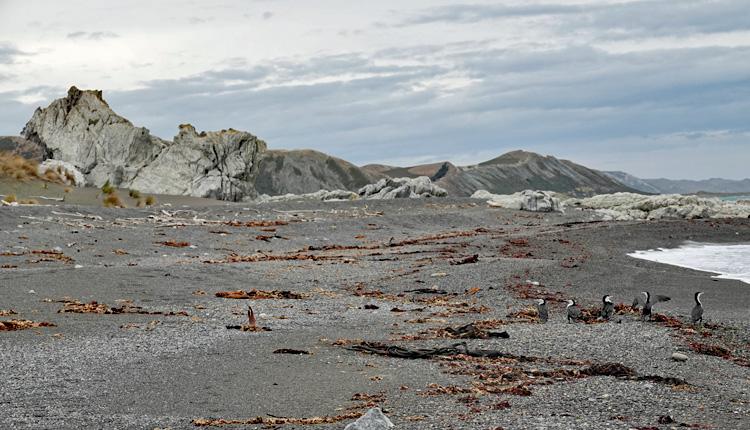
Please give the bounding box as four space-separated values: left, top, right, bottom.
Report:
0 199 750 429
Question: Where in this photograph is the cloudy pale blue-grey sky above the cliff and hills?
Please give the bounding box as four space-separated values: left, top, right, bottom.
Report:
0 0 750 179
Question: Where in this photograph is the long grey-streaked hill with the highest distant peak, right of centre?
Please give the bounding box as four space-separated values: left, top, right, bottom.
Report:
363 150 637 196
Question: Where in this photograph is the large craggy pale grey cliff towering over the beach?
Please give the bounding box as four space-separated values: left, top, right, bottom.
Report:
22 87 266 201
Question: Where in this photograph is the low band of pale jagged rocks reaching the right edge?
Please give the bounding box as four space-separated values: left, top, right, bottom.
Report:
564 193 750 221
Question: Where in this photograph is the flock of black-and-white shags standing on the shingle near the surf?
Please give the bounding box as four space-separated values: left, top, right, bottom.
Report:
536 291 703 324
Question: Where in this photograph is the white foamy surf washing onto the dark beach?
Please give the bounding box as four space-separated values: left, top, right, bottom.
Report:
628 242 750 284
